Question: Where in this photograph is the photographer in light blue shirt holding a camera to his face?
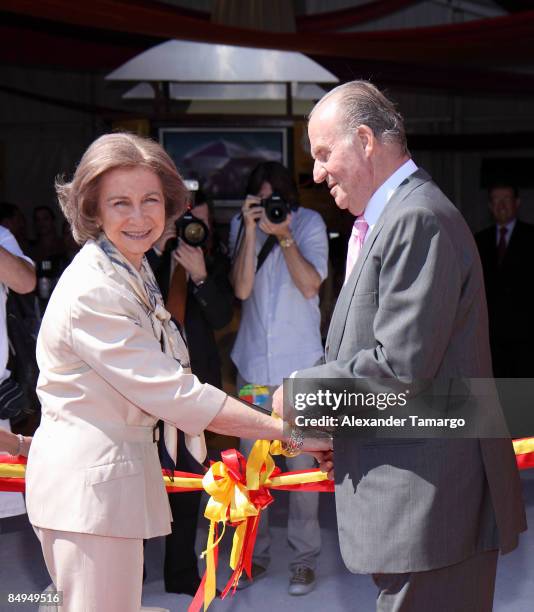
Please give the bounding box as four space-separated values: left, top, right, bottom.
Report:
230 162 328 595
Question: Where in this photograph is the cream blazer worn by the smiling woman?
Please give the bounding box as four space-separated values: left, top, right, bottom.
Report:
26 241 226 538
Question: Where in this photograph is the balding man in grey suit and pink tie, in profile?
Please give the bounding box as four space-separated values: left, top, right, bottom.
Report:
273 81 525 612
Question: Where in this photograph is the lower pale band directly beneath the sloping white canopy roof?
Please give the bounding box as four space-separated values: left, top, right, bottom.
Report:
122 82 326 100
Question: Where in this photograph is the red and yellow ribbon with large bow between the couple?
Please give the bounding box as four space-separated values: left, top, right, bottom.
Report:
0 437 534 612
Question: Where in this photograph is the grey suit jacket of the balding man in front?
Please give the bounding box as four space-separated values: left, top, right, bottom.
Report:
296 170 526 573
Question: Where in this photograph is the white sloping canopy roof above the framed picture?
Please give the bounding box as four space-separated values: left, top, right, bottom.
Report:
106 40 339 83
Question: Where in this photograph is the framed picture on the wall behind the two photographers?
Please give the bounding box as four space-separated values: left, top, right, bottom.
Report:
159 127 288 209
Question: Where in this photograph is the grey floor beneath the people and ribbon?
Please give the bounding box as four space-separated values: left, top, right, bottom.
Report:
0 470 534 612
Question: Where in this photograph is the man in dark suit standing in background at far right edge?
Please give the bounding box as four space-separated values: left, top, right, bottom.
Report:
475 183 534 378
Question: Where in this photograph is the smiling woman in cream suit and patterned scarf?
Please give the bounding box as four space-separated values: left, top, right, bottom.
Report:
27 134 330 612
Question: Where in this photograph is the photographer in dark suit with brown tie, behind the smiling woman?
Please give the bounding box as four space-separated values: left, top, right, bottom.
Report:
147 191 234 595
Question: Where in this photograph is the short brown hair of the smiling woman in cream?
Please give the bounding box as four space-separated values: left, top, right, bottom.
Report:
56 132 188 244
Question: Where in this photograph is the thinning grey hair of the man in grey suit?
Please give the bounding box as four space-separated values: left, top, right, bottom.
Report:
308 81 408 153
